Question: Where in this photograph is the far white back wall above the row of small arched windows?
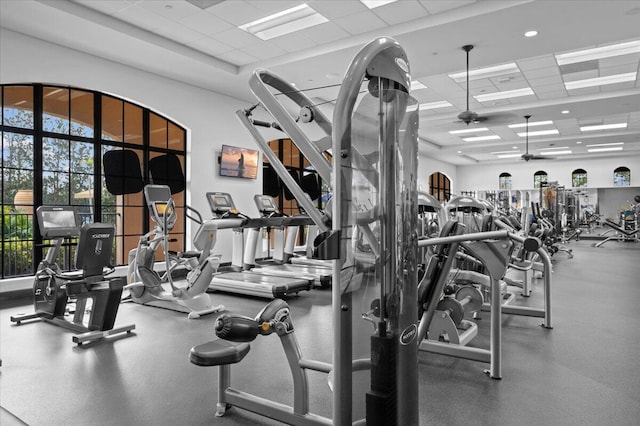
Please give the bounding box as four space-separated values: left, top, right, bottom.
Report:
457 155 640 191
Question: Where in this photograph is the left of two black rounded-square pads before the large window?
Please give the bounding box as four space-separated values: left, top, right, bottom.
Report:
102 149 144 195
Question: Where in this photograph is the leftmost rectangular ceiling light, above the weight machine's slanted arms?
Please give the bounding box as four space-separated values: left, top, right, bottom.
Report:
238 3 329 40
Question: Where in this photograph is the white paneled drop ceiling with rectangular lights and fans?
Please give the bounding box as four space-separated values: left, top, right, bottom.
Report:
0 0 640 164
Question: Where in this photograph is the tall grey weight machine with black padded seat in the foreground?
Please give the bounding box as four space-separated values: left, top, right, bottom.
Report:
190 38 419 426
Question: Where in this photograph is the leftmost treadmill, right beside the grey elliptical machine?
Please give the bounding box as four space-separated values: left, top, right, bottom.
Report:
207 192 313 299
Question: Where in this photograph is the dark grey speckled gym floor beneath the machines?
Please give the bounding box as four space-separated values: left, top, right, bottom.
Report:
0 240 640 426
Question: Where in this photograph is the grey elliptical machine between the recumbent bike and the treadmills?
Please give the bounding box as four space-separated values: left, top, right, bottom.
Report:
126 185 224 319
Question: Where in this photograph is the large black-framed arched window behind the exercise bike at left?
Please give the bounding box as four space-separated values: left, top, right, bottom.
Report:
0 84 186 278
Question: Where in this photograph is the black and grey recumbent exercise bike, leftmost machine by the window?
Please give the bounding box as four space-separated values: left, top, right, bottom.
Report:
11 206 135 345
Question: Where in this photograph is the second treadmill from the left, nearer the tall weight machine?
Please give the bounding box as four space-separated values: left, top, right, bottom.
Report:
244 194 333 287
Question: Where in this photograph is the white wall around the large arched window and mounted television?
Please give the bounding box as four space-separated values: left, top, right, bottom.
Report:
0 29 262 287
